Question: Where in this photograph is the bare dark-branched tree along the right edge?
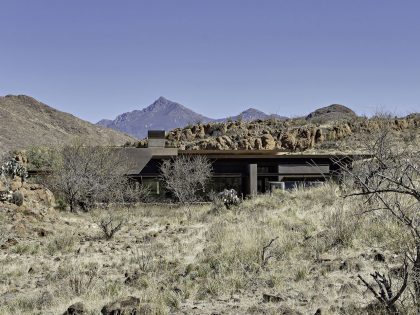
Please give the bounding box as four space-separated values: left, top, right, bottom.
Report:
337 129 420 314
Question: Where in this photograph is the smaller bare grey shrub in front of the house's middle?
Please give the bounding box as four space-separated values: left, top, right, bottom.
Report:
160 155 212 204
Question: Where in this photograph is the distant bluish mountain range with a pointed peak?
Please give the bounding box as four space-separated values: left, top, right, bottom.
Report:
97 96 285 139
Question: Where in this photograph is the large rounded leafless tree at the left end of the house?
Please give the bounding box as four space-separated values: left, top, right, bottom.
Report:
48 142 132 211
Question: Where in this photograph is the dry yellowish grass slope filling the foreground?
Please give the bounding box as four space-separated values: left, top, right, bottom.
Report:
0 183 409 314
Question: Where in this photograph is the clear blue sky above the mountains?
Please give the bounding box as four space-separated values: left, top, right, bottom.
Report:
0 0 420 122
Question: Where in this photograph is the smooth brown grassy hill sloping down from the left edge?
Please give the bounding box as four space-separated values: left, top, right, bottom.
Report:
0 95 133 152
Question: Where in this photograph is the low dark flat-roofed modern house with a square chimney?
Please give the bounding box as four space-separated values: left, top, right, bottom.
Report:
124 131 354 196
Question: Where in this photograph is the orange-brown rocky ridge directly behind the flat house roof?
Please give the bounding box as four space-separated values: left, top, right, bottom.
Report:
130 116 420 152
